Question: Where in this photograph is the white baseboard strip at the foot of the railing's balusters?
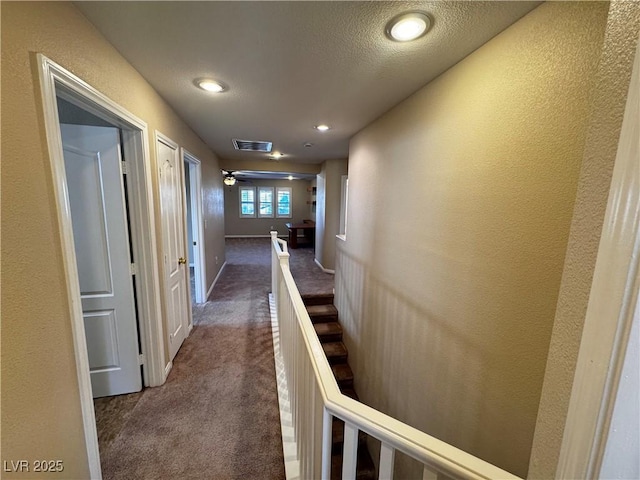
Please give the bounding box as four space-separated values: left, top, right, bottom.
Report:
269 293 300 480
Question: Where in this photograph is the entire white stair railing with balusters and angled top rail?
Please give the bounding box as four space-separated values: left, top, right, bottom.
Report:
271 232 519 480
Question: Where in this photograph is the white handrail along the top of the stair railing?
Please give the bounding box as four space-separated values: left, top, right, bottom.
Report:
272 232 520 480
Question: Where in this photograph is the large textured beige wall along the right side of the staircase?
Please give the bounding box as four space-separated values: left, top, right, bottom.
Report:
336 2 608 478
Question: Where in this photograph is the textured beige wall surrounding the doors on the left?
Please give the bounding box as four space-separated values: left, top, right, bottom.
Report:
1 2 224 479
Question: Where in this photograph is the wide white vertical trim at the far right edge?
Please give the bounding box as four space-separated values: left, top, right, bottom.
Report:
556 38 640 478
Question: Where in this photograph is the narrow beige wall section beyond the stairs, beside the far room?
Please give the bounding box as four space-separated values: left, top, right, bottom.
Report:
316 159 348 270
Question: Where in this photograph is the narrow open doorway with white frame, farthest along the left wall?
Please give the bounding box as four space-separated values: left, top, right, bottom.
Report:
182 148 207 304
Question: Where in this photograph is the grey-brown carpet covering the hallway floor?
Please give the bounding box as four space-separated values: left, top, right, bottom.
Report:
96 239 333 479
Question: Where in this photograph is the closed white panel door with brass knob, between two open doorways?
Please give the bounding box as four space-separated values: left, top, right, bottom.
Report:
156 137 191 360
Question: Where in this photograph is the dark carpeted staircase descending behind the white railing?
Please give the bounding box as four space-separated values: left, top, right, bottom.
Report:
302 293 377 480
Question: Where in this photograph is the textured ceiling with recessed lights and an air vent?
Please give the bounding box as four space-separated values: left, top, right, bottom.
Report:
75 1 540 163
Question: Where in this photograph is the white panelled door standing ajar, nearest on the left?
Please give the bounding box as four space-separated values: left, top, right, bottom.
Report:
60 124 142 398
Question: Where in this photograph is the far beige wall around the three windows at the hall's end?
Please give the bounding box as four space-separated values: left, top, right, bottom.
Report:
224 180 311 236
